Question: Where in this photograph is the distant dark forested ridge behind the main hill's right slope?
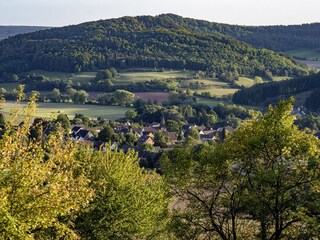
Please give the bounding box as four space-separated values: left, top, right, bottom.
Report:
161 14 320 52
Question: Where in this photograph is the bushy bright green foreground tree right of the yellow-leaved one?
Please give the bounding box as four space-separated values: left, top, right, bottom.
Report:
76 149 169 239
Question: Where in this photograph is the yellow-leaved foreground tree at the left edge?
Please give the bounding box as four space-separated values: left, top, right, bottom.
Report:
0 99 93 239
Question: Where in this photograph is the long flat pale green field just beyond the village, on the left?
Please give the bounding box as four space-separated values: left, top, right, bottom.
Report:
2 102 130 120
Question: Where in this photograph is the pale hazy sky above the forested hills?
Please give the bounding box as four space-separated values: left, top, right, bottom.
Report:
0 0 320 27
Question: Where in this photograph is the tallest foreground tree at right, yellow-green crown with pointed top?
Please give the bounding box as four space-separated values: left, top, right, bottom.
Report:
221 99 319 239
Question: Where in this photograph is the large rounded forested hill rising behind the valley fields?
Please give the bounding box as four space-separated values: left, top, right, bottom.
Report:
0 15 307 76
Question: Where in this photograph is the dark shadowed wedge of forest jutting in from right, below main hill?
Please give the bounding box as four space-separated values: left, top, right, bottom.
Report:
232 73 320 105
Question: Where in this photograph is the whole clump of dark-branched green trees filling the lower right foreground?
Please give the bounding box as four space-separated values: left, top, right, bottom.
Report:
162 99 320 240
